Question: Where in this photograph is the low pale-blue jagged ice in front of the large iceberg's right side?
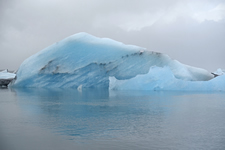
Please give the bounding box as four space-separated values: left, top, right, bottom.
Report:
109 67 225 91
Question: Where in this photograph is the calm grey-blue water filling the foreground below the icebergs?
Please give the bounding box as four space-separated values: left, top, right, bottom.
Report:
0 88 225 150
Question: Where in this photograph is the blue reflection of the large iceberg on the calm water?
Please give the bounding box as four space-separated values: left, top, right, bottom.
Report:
13 88 178 138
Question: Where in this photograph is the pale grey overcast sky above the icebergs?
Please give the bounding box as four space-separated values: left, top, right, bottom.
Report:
0 0 225 71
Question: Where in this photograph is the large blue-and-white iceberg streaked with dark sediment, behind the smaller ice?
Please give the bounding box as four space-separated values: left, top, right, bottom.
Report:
11 33 213 88
